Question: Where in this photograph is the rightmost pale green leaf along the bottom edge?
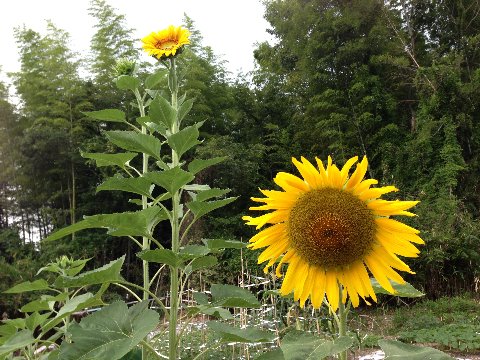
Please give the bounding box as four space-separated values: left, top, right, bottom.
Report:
378 339 453 360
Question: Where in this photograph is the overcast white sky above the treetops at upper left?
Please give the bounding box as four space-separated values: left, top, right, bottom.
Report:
0 0 271 86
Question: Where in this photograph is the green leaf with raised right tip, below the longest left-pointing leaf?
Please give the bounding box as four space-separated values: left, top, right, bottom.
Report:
55 255 125 288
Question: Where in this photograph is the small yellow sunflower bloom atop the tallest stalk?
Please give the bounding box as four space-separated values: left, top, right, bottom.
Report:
142 25 190 59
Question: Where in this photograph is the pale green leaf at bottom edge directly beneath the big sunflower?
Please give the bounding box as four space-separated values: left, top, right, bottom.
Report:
280 330 353 360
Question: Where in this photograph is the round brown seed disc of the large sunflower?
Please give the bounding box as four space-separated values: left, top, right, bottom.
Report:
287 188 376 269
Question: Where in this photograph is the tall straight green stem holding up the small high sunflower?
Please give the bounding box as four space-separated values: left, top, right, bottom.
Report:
168 58 180 360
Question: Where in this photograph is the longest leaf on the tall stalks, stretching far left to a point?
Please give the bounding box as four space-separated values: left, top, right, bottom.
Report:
44 206 168 241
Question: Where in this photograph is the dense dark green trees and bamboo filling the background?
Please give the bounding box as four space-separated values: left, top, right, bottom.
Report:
0 0 480 314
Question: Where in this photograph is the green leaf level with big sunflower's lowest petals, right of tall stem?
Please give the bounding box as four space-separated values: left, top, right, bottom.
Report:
210 284 260 308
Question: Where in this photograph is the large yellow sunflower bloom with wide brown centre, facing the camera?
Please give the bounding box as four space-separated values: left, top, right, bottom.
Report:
243 156 424 311
